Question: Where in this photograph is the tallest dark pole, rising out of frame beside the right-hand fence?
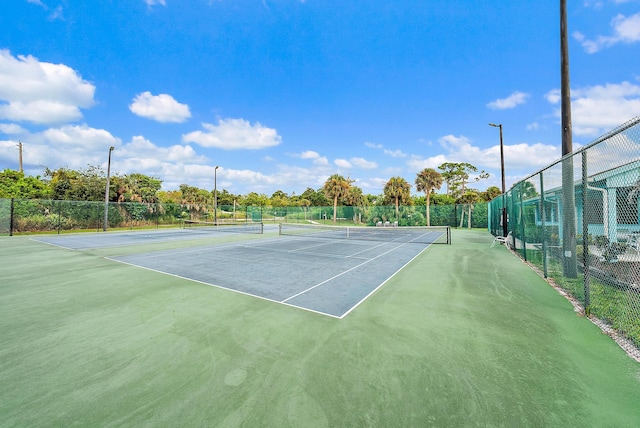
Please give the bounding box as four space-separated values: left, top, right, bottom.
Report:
560 0 578 278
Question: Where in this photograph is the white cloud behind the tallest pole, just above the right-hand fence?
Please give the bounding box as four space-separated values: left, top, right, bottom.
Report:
547 82 640 136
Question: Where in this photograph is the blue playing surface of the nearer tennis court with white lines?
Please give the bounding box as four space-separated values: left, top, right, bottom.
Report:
110 236 436 318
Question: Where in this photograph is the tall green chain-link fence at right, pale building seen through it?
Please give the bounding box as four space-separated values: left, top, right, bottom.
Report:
488 117 640 348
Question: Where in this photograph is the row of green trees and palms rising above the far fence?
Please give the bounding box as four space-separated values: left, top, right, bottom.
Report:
0 162 501 224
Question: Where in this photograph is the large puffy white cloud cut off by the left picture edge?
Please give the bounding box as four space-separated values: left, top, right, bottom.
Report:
0 50 95 124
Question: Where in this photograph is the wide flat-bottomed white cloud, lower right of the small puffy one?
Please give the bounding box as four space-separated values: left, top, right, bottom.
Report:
182 119 282 150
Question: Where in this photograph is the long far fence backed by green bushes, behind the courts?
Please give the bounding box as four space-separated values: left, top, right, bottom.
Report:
0 199 488 235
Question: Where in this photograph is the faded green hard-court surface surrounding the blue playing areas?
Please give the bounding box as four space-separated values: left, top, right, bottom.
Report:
0 230 640 427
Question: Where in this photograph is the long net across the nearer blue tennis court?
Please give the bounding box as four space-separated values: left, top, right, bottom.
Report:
279 223 451 244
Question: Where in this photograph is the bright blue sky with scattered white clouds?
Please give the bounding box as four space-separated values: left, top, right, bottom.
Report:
0 0 640 195
